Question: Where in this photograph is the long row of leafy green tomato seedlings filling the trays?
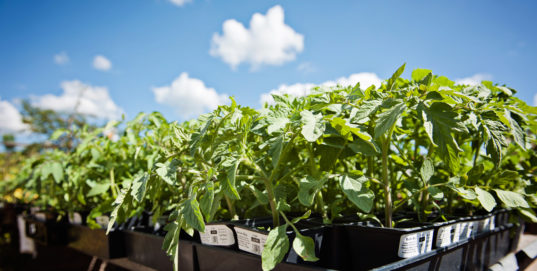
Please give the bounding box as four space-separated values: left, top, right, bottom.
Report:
1 65 537 270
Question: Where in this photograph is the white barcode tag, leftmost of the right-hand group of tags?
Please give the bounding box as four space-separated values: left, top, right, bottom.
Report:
398 230 434 258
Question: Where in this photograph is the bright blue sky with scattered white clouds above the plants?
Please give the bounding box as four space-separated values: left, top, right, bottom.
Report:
0 0 537 133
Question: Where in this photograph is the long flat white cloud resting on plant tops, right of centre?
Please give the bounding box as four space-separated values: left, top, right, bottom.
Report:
259 72 382 104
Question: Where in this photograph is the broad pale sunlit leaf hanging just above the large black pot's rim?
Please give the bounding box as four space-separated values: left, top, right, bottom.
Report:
339 175 375 213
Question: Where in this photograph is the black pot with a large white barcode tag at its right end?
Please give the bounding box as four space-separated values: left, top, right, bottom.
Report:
341 222 434 270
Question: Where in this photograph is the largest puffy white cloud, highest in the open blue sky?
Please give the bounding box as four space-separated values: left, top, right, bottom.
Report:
209 5 304 69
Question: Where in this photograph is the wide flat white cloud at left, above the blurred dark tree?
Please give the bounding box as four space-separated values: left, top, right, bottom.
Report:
31 80 123 119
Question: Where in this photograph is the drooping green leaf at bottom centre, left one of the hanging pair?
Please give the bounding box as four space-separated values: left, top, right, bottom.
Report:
261 224 289 271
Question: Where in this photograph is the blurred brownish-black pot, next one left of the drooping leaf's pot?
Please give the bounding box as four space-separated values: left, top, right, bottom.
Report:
68 225 125 259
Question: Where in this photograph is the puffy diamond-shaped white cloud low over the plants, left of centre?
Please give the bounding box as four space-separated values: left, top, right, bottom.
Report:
153 72 228 119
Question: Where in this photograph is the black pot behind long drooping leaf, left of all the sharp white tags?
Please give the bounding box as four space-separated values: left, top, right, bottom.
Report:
123 230 197 271
